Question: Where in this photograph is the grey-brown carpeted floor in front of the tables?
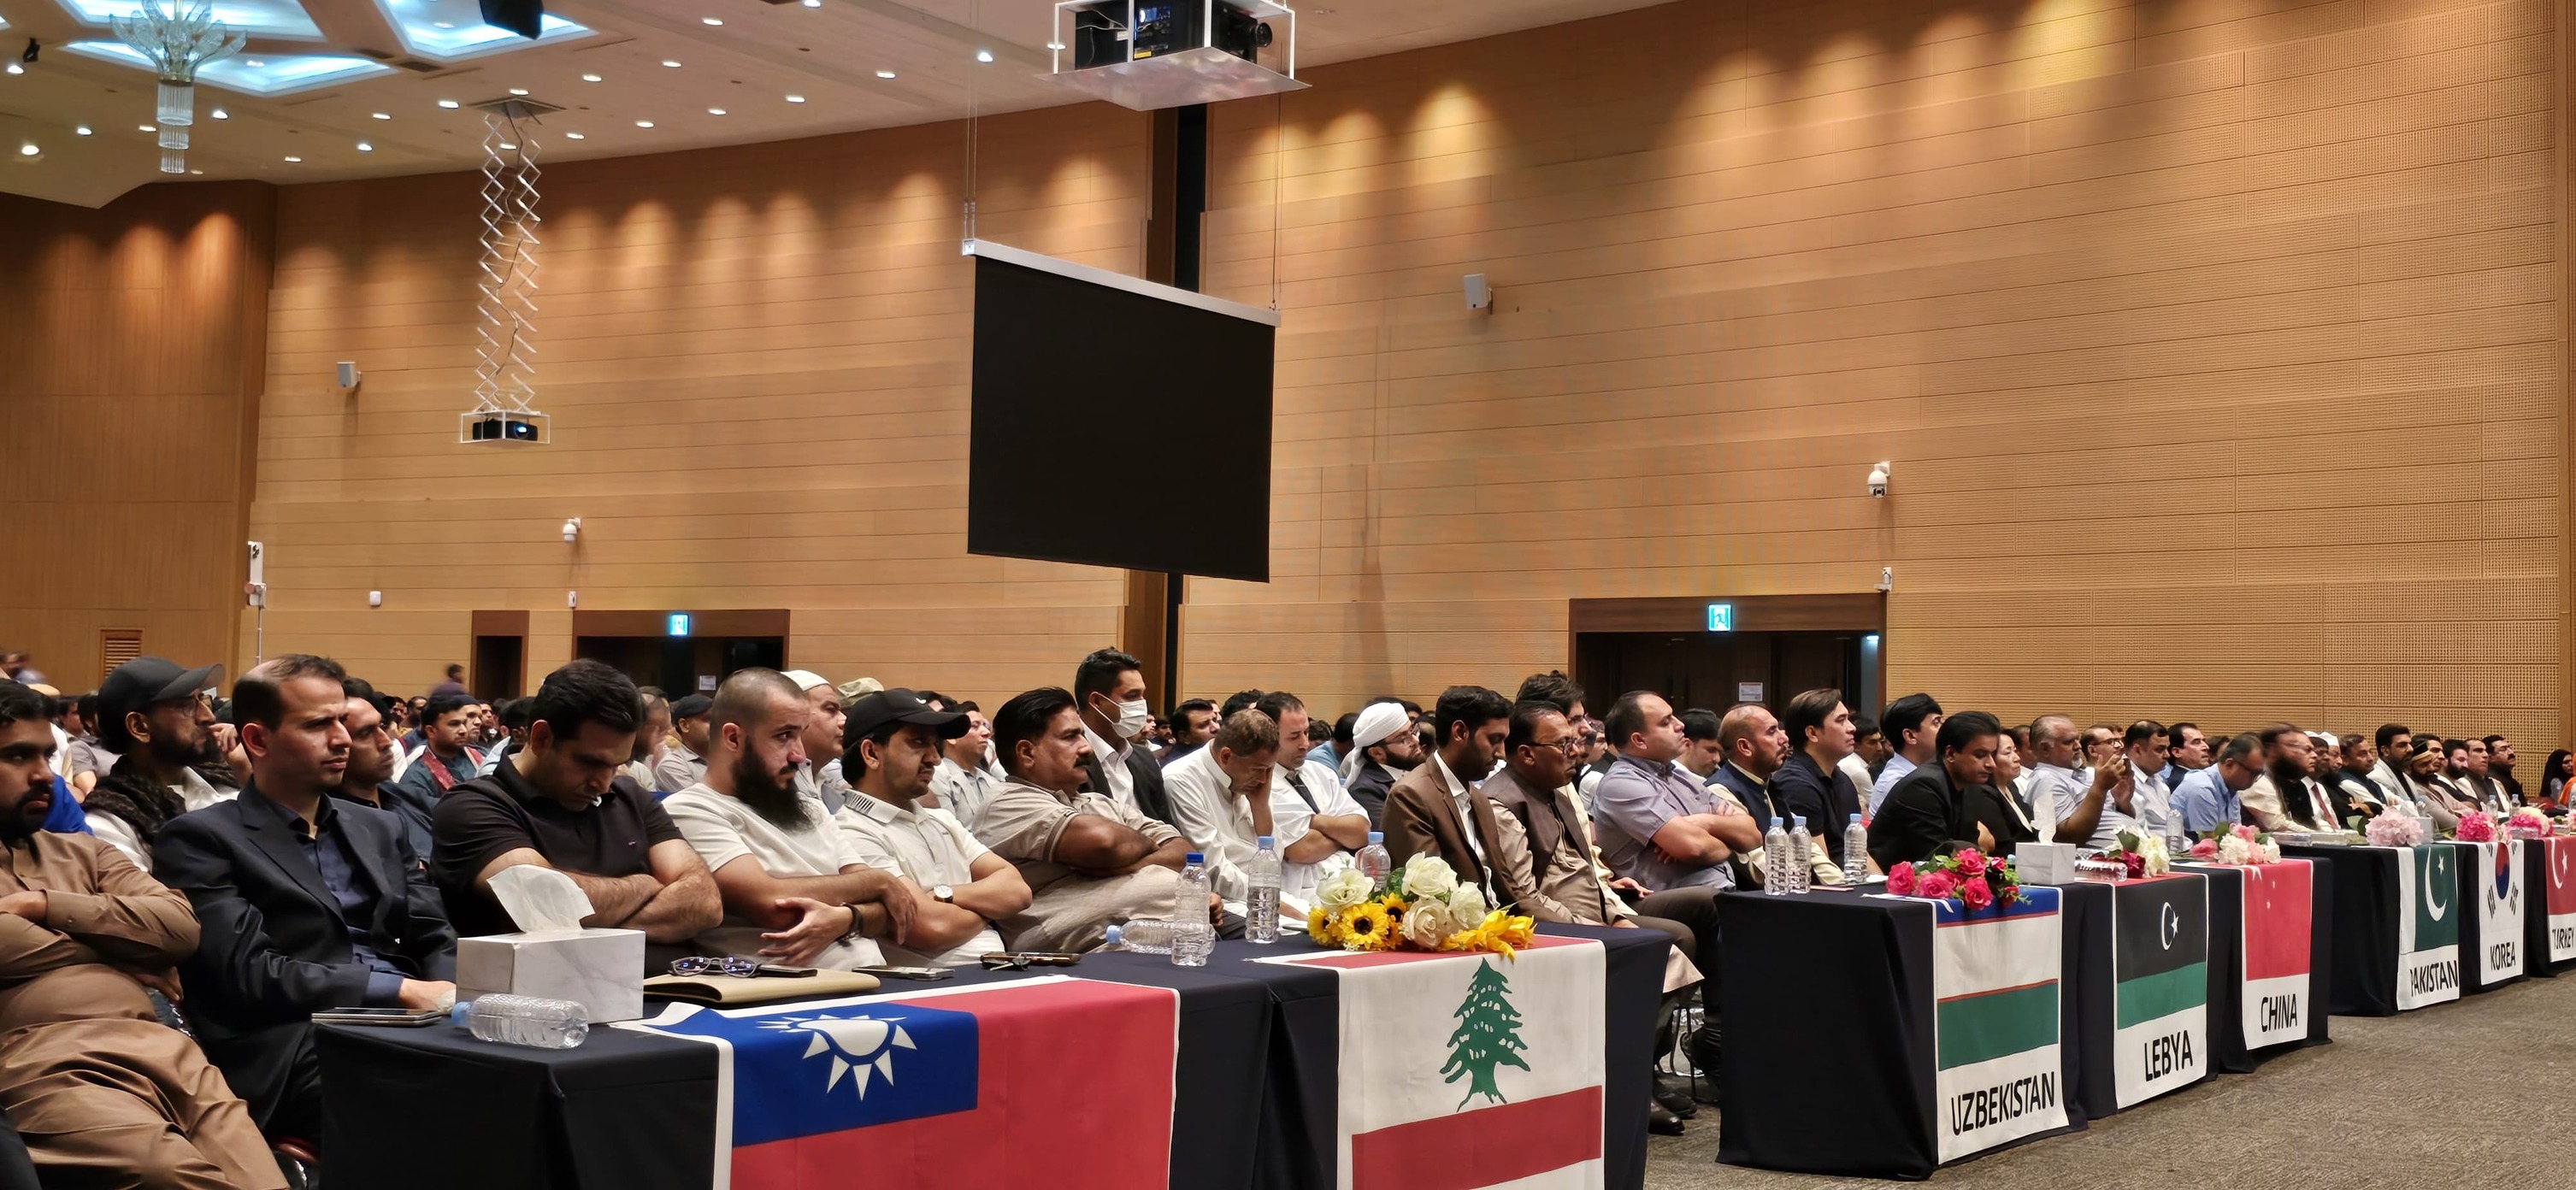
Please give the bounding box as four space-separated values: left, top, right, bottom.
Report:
1646 974 2576 1190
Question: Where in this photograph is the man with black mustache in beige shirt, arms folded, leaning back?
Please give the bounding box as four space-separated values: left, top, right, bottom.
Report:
974 687 1213 951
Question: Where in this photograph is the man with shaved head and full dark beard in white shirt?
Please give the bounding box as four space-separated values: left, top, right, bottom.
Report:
662 669 912 971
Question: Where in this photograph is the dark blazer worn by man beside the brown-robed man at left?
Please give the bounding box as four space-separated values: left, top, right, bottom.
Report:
152 788 456 1121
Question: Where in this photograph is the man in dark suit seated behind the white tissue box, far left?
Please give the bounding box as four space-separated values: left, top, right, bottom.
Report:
152 654 456 1139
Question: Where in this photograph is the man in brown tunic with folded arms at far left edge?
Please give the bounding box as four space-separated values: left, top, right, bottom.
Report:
0 682 286 1190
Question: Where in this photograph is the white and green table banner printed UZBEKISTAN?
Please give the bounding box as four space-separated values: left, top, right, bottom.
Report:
1932 888 2066 1162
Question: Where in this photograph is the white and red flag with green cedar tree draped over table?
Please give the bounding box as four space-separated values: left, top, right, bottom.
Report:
1262 938 1605 1190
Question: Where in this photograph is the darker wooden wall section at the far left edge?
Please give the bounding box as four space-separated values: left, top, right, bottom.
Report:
0 183 275 692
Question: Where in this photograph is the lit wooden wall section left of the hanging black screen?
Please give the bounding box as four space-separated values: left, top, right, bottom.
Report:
252 106 1147 704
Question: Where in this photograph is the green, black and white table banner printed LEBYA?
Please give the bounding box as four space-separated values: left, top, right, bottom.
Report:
2110 873 2210 1108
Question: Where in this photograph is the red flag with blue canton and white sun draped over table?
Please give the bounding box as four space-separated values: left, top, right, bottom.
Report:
621 976 1180 1190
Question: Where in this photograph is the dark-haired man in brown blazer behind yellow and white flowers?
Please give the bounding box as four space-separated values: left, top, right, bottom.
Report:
1381 685 1504 910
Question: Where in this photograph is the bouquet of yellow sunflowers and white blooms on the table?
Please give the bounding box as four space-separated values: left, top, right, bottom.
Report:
1306 855 1533 958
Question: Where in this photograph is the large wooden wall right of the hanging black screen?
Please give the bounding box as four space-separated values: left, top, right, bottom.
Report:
1182 0 2568 739
